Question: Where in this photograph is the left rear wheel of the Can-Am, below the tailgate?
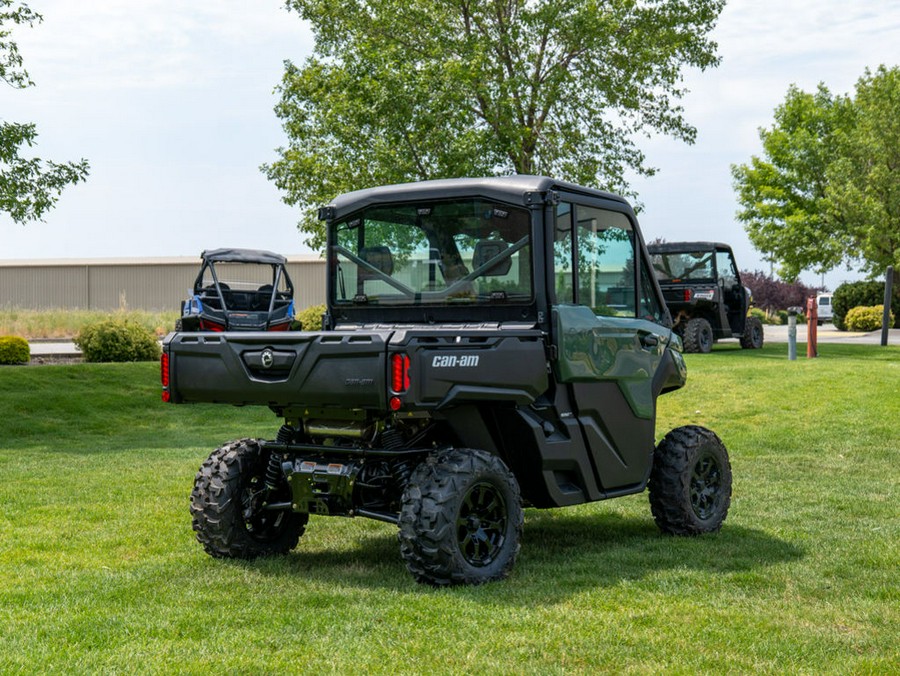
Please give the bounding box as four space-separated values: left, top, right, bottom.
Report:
191 439 309 559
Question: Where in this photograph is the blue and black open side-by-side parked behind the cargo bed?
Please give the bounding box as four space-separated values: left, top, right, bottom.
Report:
175 249 294 331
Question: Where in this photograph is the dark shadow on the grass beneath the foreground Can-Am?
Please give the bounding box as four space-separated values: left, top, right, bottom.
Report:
225 510 803 605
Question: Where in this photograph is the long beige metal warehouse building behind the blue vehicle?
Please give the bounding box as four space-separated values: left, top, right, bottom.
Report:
0 254 325 311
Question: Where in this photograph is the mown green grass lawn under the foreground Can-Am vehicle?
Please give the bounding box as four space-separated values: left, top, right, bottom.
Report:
0 345 900 674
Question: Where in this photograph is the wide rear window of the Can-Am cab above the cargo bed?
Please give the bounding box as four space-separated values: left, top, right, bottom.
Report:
331 199 532 305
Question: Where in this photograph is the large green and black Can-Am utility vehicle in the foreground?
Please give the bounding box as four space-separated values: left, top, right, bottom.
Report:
162 176 731 585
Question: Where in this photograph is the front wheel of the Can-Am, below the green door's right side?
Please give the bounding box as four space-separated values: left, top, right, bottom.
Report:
648 425 731 535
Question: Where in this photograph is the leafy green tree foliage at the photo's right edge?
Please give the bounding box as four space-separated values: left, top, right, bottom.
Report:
732 66 900 288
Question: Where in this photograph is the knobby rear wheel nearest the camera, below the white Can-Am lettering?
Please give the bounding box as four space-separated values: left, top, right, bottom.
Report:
399 449 524 586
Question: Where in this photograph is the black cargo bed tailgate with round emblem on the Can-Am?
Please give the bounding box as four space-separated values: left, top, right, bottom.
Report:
163 331 391 408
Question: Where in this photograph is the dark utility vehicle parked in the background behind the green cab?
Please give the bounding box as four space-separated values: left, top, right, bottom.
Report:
647 242 763 352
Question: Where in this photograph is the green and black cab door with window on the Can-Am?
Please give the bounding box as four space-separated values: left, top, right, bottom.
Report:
548 196 685 492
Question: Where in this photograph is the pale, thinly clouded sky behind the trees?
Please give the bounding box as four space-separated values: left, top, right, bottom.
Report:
0 0 900 289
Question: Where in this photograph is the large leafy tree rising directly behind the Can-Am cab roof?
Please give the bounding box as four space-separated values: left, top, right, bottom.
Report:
263 0 724 245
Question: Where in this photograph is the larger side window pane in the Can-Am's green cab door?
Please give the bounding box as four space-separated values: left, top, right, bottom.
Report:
575 205 636 317
